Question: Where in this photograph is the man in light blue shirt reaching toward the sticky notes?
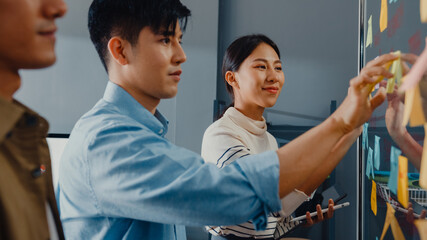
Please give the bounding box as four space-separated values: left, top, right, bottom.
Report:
58 0 395 240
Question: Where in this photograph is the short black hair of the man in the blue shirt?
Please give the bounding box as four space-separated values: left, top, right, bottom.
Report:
88 0 191 71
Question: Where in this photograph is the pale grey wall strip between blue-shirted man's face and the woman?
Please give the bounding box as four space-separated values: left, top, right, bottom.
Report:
175 0 218 153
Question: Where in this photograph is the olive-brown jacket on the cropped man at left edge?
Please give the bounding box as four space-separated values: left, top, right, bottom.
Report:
0 98 64 240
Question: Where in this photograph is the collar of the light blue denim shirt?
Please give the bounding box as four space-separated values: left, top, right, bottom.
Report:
103 81 169 137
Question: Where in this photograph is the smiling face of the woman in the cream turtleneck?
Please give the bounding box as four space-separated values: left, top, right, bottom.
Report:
233 43 285 108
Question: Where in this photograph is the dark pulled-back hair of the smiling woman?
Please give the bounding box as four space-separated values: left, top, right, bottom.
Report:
222 34 280 103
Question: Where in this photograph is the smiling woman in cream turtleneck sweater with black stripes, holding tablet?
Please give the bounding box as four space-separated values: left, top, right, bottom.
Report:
202 35 333 239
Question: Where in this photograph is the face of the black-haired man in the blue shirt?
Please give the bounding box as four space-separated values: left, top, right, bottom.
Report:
122 24 186 105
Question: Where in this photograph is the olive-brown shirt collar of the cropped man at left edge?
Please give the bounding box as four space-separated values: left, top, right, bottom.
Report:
0 97 26 142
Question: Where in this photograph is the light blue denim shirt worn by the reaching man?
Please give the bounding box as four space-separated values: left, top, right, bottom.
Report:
58 82 281 240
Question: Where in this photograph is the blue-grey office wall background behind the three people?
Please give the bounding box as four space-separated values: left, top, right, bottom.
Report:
16 0 368 239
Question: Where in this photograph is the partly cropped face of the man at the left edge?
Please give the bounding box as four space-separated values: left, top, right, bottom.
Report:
0 0 67 70
